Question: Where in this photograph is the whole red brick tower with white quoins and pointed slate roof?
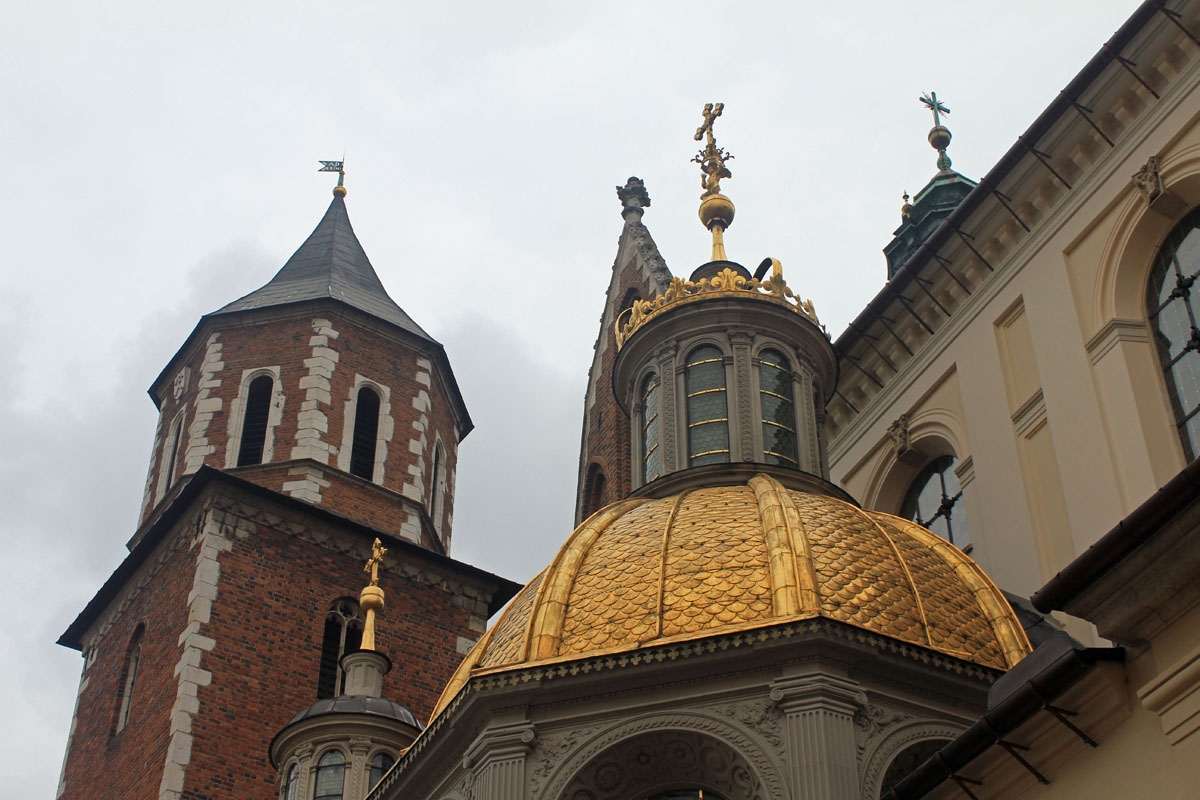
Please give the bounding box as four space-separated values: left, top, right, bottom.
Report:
58 180 518 800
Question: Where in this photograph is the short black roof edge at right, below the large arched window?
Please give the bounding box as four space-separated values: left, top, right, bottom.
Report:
1030 458 1200 613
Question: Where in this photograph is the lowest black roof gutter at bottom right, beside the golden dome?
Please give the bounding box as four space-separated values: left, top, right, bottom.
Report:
880 633 1124 800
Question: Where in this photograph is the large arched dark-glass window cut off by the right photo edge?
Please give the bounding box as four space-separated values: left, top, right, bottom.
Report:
1146 209 1200 461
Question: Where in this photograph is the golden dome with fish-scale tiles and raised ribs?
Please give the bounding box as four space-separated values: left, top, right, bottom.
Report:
434 474 1030 716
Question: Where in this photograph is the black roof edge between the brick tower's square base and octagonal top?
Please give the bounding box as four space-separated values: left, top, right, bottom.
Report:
58 467 522 650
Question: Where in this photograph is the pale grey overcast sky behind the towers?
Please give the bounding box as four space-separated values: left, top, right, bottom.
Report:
0 0 1134 798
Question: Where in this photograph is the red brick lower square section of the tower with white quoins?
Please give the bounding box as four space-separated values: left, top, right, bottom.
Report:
62 485 494 800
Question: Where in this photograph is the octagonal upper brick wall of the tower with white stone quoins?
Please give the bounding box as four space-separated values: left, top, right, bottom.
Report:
142 303 458 551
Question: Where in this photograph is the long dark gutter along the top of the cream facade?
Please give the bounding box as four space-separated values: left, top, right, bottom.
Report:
833 0 1166 359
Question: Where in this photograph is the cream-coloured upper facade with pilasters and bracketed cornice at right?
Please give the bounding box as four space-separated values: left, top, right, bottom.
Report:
828 4 1200 604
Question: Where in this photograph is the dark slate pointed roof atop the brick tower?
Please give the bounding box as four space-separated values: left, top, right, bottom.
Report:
210 194 434 342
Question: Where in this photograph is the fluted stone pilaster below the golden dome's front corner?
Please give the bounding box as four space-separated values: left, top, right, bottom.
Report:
770 673 866 800
